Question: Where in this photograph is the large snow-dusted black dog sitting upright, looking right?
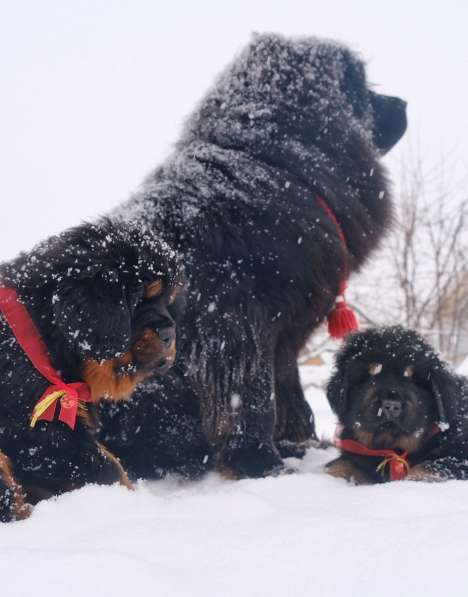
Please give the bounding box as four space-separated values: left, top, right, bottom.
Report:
109 35 406 477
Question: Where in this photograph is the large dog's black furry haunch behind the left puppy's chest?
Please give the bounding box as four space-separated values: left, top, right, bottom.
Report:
99 374 214 480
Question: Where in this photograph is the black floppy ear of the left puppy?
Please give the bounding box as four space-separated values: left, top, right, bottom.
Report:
53 269 131 360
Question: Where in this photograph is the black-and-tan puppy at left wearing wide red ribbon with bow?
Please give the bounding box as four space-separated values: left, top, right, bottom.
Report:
0 220 184 521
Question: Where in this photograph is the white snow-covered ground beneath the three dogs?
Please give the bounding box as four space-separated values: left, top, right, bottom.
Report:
0 367 468 597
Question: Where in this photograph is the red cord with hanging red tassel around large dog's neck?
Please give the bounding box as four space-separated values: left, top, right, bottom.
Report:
316 195 359 340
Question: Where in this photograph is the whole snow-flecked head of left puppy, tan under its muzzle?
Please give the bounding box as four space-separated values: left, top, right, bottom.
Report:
6 220 184 399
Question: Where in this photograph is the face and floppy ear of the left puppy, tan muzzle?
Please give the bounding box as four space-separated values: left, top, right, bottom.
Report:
49 223 184 400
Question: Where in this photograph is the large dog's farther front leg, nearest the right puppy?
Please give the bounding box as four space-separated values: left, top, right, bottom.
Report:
275 341 317 457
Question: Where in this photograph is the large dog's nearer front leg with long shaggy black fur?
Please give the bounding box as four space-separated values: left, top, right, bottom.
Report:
185 308 283 478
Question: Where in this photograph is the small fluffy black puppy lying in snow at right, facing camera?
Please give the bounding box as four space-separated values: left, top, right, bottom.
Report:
327 326 468 484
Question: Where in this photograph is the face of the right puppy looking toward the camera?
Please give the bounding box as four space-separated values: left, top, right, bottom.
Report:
343 359 437 452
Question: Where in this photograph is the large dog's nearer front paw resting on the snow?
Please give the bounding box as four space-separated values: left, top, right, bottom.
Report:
218 442 285 479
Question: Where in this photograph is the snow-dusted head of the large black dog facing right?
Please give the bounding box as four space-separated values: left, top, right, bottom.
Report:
196 33 407 156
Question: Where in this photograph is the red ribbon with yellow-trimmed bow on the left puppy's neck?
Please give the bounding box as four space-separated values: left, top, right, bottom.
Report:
0 286 91 429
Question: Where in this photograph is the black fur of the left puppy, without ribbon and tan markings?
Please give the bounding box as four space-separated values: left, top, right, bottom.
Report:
0 220 184 520
